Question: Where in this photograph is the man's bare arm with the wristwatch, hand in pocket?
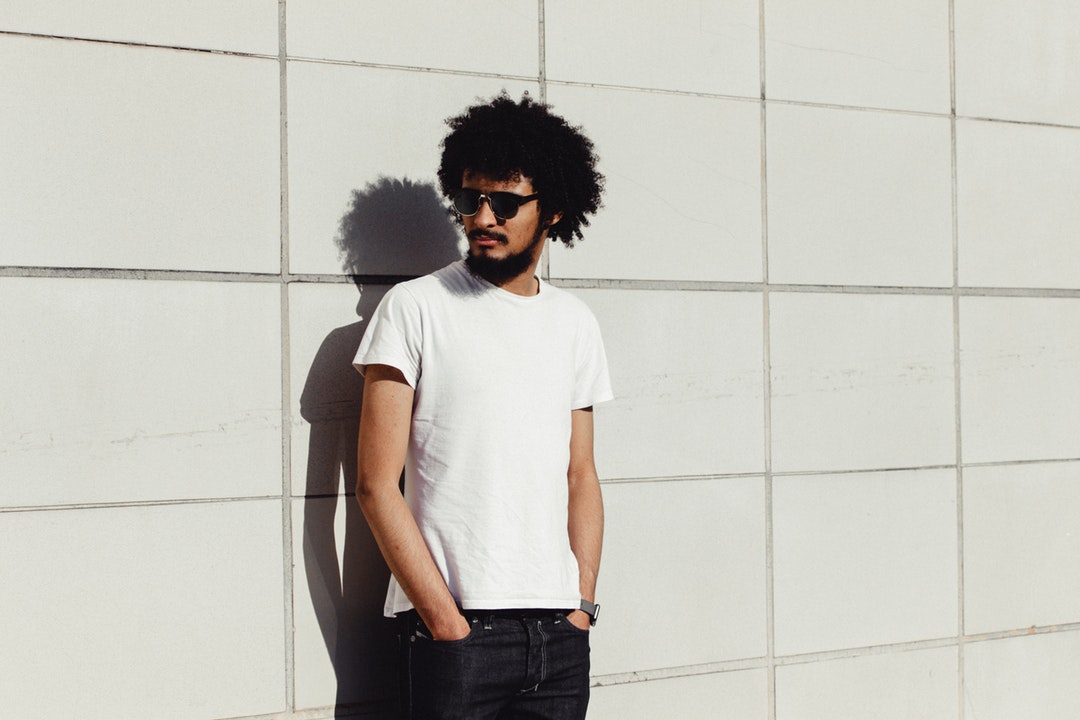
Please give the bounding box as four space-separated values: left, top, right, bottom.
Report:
566 407 604 629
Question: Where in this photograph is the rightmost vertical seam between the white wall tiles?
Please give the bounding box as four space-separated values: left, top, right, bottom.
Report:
948 0 967 720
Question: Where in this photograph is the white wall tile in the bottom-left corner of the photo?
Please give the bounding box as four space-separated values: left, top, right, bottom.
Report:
0 501 286 720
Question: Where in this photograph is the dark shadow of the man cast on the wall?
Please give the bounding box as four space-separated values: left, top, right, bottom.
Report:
300 177 461 718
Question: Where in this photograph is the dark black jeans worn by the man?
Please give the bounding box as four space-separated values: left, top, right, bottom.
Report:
402 610 589 720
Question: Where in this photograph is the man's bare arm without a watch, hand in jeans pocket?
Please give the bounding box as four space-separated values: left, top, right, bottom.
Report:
356 365 469 640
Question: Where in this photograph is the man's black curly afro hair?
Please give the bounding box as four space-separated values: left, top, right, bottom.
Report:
438 91 604 247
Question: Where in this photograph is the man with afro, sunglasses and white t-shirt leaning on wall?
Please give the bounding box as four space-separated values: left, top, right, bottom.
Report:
355 93 611 720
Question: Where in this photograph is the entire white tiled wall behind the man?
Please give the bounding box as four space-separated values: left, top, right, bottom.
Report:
0 0 1080 720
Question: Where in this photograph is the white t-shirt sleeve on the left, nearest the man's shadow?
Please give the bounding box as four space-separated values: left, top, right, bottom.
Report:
352 285 422 389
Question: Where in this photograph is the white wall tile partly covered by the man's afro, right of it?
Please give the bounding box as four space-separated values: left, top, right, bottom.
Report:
548 87 761 282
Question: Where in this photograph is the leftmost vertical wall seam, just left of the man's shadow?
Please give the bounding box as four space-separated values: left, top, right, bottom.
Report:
278 0 296 716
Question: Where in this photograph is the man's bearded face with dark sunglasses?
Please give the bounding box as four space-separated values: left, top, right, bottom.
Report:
461 171 558 285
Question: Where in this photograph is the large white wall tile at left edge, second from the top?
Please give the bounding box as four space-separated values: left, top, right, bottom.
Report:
0 37 281 272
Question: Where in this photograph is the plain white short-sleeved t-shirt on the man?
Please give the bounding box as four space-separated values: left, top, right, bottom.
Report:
354 261 612 615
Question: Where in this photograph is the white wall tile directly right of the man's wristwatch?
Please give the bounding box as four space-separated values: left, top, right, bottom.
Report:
592 477 766 675
